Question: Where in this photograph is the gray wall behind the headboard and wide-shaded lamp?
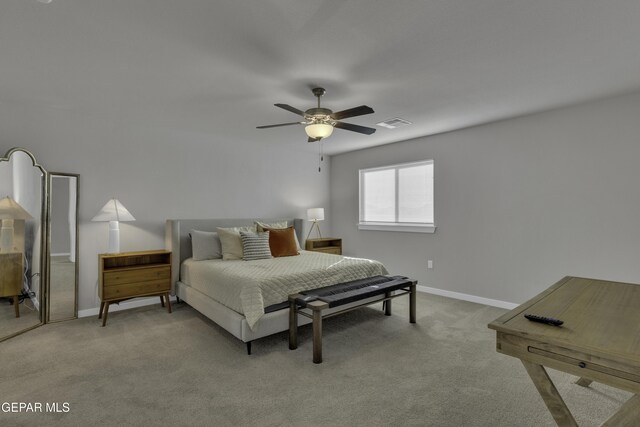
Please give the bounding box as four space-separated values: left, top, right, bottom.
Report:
0 107 330 310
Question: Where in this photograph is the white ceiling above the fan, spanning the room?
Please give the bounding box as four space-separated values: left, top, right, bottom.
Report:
0 0 640 154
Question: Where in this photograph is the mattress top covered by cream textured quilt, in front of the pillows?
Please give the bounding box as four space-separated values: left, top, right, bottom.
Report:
180 251 388 329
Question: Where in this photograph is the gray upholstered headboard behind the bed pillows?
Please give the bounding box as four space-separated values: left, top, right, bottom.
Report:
165 218 304 288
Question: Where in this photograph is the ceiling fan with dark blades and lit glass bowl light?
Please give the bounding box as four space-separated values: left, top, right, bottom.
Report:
257 87 376 142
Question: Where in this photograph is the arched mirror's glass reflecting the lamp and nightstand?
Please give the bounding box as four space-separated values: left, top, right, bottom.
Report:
0 148 47 341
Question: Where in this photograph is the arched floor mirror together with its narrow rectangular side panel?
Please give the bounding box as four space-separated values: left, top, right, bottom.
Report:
0 148 80 341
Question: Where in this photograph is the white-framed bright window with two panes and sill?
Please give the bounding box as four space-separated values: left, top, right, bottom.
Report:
358 160 435 233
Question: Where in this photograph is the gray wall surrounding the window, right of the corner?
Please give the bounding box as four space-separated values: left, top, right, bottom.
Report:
330 93 640 303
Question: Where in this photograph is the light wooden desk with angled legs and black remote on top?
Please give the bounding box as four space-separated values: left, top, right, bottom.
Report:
489 277 640 426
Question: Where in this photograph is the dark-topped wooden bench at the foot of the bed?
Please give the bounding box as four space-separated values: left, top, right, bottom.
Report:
288 276 418 363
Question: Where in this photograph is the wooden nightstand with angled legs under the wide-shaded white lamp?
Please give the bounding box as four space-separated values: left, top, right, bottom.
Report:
98 250 171 326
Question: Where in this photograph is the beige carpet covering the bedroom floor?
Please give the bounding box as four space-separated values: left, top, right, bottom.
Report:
0 294 630 427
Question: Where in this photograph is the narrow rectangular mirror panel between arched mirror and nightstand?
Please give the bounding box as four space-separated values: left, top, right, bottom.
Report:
47 172 80 322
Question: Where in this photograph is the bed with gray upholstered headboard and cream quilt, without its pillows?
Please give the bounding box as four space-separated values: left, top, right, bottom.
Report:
165 219 387 354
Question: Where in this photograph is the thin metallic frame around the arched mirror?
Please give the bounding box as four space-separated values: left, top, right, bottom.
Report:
0 147 49 342
